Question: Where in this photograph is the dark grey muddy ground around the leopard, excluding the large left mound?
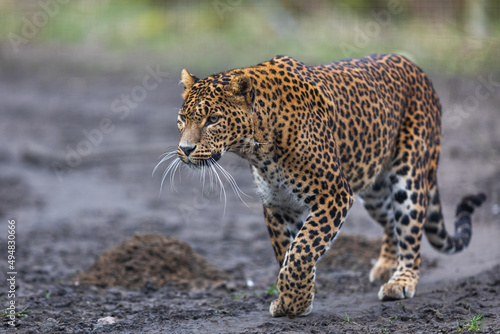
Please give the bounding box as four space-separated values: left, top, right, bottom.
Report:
0 46 500 333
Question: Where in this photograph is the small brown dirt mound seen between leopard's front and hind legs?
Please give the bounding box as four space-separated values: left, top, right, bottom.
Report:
319 234 382 270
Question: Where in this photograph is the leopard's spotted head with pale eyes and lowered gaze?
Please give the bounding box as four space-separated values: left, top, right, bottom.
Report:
177 69 254 168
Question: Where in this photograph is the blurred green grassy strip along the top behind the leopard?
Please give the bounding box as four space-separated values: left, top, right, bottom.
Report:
0 0 500 76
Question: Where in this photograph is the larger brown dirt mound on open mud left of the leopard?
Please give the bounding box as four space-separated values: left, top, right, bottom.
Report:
78 234 226 289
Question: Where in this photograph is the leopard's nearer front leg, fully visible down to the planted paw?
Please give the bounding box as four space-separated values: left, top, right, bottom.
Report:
270 188 353 318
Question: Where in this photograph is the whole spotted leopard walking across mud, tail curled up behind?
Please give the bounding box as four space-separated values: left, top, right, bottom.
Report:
162 54 486 319
